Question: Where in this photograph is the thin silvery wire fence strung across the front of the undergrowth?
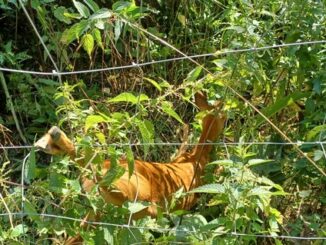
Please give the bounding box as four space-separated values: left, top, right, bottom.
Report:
0 0 326 244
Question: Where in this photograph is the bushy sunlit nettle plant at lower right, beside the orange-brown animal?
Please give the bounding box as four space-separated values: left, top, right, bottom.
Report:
191 143 287 241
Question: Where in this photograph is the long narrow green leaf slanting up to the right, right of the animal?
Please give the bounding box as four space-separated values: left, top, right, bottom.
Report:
255 92 309 126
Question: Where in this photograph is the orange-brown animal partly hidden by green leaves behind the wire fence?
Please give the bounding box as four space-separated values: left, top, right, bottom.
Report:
35 93 225 244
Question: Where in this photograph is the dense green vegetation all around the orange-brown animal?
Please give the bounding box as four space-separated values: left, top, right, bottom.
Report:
0 0 326 244
